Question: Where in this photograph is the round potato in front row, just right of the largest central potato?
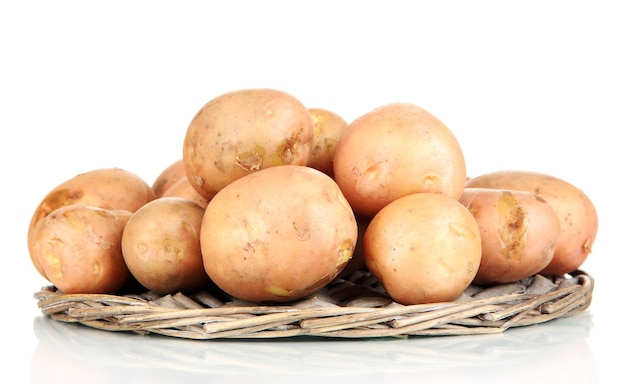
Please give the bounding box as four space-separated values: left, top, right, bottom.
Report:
363 192 482 305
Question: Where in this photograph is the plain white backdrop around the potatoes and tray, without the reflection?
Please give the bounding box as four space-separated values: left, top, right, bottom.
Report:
0 0 626 382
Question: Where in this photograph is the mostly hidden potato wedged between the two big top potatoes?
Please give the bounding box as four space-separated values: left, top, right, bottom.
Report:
308 108 348 177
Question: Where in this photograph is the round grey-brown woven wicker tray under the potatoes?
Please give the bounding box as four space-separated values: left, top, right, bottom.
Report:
34 271 594 340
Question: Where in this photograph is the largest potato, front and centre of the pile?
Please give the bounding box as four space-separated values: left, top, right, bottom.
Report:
200 165 358 302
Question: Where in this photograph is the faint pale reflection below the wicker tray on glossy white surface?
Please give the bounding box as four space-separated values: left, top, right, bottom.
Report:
31 312 598 384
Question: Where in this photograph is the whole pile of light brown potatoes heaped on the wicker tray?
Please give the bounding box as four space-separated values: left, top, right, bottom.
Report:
28 89 598 305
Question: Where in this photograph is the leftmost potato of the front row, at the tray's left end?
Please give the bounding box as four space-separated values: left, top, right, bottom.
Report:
32 205 131 294
